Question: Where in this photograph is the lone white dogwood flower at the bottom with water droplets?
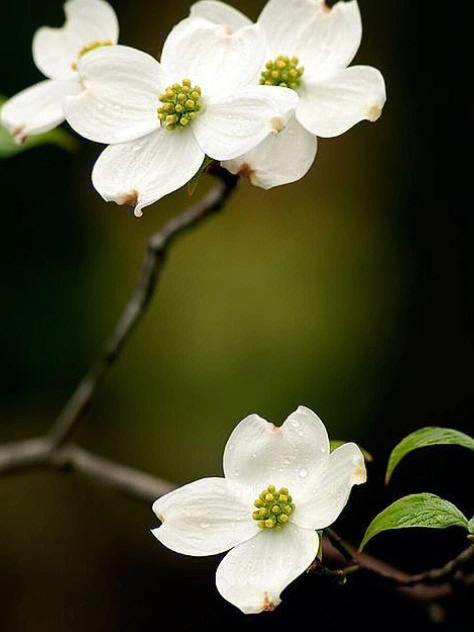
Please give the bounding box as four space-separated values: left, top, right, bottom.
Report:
153 406 366 614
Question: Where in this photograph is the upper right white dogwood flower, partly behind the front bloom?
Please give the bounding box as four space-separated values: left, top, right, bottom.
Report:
191 0 386 189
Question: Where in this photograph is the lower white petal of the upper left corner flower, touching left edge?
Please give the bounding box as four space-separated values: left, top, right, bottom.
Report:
1 78 81 142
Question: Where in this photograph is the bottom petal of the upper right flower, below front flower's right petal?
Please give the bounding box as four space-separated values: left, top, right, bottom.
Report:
222 117 318 189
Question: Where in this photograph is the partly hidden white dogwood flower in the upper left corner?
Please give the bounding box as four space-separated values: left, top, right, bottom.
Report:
1 0 119 143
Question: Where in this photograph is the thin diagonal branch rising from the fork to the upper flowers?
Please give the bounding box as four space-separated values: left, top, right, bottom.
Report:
49 163 239 448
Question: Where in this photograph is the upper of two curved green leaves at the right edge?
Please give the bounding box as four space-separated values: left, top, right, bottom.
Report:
385 427 474 484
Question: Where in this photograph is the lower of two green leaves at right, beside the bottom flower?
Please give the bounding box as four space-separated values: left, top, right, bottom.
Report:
360 494 468 551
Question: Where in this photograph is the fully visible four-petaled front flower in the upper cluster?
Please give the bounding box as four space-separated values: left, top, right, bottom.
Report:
59 18 297 216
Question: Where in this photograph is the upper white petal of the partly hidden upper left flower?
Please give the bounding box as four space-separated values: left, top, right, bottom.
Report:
33 0 119 78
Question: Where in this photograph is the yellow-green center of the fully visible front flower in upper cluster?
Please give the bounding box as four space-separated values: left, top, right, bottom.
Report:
158 79 202 131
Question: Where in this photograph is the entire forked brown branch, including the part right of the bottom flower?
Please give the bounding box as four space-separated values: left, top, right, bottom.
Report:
0 163 474 616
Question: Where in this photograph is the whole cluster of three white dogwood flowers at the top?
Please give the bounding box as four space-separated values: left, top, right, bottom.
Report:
1 0 386 215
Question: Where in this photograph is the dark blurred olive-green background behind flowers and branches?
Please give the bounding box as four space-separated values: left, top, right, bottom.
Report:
0 0 474 632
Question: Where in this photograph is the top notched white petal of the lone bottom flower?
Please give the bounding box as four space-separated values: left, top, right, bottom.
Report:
224 406 329 498
